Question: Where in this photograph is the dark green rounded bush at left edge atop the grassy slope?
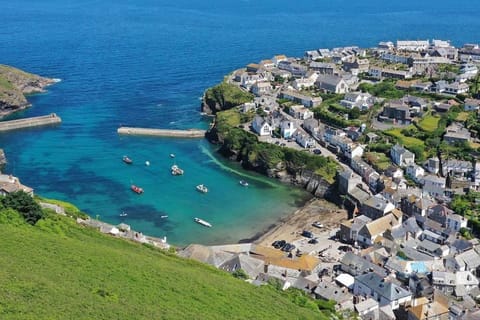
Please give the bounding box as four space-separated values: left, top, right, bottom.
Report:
1 191 43 225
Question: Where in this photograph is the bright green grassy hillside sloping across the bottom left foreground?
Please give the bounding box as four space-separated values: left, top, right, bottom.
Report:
0 196 327 319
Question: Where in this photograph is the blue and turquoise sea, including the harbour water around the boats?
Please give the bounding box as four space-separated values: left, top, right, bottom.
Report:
0 0 480 246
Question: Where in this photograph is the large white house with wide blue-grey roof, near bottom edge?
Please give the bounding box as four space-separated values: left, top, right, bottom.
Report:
353 272 412 310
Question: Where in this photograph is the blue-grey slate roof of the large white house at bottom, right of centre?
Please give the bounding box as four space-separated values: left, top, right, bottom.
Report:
355 272 412 301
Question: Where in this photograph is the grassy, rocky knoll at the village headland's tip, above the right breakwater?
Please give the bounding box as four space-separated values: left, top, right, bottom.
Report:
203 81 253 113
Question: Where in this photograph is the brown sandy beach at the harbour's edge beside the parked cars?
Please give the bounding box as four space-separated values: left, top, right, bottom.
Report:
251 198 348 246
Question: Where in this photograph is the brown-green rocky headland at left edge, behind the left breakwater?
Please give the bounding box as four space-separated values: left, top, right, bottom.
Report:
0 65 55 116
